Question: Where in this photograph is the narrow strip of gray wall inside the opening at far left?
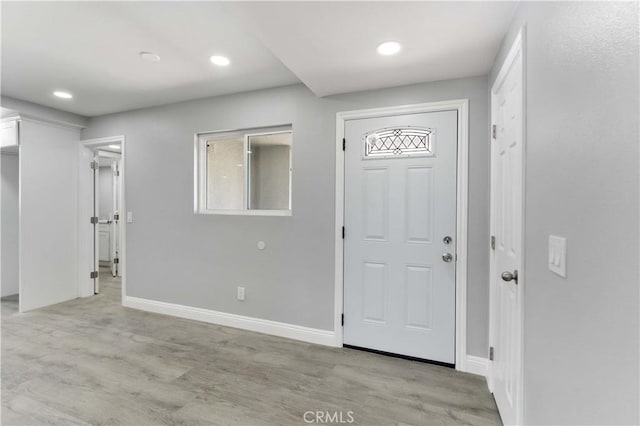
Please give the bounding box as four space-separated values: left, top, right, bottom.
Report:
0 153 18 297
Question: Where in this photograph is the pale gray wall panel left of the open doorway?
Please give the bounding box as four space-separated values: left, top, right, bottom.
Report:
19 120 81 312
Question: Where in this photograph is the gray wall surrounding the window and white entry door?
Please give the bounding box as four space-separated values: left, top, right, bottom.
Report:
83 77 489 356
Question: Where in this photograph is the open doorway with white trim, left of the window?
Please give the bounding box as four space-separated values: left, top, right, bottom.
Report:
78 136 125 298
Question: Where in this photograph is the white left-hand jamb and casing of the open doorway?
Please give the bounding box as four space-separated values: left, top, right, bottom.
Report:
78 145 100 297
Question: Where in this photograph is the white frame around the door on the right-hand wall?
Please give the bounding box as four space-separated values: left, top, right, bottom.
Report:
487 27 527 425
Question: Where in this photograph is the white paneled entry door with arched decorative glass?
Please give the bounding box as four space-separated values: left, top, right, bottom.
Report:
344 111 458 364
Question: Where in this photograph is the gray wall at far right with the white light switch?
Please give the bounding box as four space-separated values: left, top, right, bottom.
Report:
490 2 640 425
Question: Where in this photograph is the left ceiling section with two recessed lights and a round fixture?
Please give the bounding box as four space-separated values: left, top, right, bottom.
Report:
1 2 299 116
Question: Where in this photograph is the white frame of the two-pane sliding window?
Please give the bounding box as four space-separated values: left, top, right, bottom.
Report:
194 124 293 216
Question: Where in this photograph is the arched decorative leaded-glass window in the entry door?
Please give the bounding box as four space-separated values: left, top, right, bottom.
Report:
364 127 433 158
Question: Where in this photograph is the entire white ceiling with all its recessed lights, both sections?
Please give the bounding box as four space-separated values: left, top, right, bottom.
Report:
0 1 517 116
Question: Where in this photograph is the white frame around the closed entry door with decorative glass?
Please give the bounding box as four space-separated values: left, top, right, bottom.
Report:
334 99 469 371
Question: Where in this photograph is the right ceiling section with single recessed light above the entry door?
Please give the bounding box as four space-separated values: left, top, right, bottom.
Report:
234 1 517 96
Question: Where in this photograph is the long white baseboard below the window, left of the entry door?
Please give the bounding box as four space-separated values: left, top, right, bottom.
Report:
122 296 337 347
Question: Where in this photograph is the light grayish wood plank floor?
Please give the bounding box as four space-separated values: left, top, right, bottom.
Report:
1 272 500 426
